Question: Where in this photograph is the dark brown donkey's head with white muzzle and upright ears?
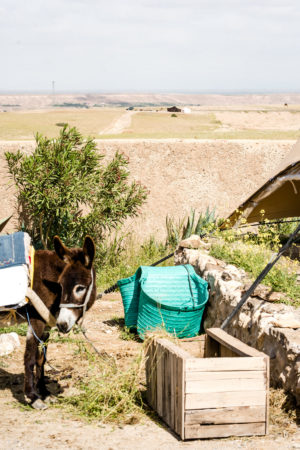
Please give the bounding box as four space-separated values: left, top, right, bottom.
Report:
54 236 96 333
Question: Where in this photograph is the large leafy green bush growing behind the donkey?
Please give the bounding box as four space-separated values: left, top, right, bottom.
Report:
5 126 147 255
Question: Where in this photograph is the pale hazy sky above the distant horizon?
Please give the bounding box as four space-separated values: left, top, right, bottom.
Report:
0 0 300 92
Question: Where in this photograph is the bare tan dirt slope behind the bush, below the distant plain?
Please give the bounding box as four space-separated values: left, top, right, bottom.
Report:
0 139 295 240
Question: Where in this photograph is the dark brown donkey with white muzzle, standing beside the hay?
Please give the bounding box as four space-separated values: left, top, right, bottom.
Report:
24 236 96 409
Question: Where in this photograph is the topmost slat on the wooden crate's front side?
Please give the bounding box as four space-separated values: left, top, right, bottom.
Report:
186 357 266 372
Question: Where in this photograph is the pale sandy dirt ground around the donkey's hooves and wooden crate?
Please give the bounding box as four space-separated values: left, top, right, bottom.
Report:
0 294 300 450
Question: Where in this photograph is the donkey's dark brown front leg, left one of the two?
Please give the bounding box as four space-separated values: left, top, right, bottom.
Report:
24 319 45 409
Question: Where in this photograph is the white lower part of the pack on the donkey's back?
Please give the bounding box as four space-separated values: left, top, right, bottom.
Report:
0 265 28 310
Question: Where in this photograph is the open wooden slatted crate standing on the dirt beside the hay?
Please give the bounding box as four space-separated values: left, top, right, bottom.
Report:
146 328 269 440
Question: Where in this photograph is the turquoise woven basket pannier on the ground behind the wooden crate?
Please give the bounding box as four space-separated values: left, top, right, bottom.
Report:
118 265 208 339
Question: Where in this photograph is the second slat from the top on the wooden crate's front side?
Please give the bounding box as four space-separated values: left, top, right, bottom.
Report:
185 377 266 394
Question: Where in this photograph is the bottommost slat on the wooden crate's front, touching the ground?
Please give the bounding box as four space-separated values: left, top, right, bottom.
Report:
184 422 265 439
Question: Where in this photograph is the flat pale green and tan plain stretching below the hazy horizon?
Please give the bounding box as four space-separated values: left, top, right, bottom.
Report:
0 108 300 140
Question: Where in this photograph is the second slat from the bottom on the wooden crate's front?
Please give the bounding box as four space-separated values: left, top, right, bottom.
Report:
185 406 266 425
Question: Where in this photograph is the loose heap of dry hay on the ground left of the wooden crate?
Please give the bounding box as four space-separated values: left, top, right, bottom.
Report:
60 343 145 424
